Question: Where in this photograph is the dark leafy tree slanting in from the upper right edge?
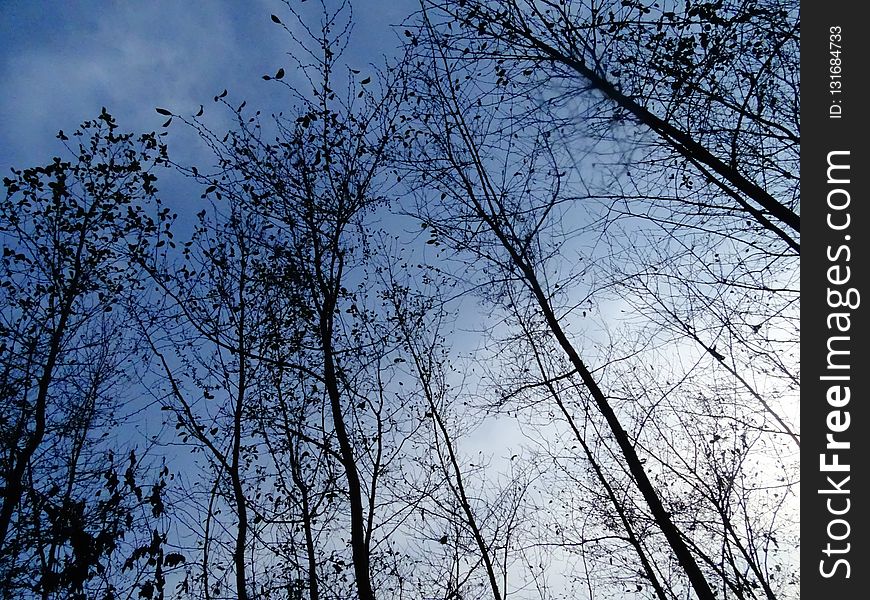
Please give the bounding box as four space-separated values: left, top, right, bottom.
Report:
427 0 800 253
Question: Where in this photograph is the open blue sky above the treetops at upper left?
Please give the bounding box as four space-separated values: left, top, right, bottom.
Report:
0 0 416 178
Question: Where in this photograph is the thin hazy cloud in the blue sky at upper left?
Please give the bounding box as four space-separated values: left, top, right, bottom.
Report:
0 0 281 171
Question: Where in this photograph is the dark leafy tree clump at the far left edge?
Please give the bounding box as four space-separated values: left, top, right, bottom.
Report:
0 109 177 598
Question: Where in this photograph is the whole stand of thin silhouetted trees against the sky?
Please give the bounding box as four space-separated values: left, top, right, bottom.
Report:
0 0 801 600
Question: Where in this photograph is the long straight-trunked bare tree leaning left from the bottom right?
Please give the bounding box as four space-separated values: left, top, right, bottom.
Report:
398 14 792 598
